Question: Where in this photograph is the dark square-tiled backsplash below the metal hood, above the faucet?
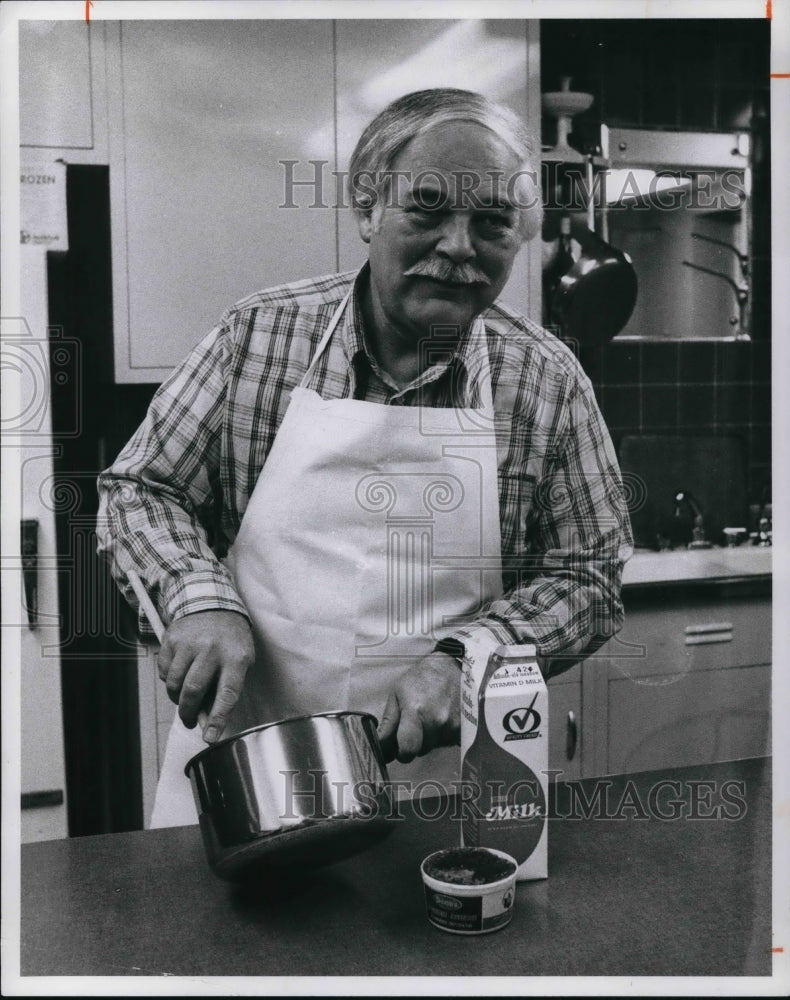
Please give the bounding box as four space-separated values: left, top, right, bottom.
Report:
586 339 771 502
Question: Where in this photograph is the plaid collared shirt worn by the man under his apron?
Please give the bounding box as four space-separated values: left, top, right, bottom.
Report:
98 265 632 659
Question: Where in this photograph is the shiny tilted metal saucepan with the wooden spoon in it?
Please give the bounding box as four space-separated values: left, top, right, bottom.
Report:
129 573 395 882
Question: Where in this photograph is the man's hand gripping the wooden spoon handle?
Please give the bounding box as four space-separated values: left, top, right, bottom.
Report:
158 611 255 743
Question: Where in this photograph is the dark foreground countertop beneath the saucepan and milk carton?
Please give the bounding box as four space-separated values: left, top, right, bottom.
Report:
21 758 772 977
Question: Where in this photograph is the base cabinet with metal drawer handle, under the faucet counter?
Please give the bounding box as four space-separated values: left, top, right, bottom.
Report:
584 598 771 775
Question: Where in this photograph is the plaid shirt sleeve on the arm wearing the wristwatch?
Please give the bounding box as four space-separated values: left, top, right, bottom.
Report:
453 376 633 675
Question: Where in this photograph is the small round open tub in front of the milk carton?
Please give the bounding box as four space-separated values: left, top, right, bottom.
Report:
420 847 518 934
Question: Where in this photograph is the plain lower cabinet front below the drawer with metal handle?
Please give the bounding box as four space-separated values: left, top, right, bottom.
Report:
607 666 771 774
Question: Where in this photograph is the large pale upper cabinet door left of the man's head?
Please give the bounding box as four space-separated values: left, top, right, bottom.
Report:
108 20 337 382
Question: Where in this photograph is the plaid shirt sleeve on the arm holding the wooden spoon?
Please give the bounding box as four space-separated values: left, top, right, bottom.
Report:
97 323 247 634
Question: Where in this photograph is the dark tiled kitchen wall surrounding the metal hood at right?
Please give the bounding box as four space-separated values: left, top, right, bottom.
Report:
541 18 771 502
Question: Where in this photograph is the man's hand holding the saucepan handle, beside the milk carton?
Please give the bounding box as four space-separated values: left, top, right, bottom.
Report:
379 653 461 764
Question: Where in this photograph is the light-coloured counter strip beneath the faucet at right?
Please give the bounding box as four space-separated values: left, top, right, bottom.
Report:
623 545 772 585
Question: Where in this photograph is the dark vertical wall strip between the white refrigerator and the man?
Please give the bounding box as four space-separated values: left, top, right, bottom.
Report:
48 165 158 836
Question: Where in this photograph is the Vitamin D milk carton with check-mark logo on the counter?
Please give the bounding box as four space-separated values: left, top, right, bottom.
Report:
461 640 549 881
